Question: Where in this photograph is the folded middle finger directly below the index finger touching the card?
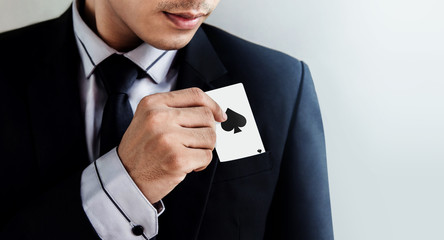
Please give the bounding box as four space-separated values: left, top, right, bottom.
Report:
174 107 216 129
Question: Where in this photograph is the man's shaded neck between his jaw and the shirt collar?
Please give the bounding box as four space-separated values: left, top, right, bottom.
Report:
79 0 142 52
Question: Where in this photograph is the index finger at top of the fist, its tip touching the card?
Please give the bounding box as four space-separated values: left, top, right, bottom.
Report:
150 88 227 122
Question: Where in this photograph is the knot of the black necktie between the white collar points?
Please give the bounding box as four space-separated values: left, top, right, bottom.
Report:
96 54 142 94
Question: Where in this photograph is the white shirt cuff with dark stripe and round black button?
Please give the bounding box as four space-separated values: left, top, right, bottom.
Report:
81 148 164 240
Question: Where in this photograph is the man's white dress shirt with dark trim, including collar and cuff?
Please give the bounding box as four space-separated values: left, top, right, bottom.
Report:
72 0 178 240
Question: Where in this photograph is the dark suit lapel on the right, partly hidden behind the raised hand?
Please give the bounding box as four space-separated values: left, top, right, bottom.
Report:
157 26 231 240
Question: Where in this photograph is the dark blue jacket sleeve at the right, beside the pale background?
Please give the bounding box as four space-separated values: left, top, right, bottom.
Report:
266 63 333 240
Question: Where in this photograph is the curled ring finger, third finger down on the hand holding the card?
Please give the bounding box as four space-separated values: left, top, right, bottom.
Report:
179 127 216 150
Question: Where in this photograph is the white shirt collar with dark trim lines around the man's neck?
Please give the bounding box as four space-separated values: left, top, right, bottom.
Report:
72 0 177 83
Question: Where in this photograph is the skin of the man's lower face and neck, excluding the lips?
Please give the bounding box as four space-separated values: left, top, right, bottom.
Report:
85 0 219 52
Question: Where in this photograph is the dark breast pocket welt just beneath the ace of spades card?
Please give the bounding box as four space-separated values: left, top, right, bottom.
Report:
214 152 272 182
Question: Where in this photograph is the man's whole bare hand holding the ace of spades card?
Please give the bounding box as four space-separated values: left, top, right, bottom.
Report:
118 88 227 203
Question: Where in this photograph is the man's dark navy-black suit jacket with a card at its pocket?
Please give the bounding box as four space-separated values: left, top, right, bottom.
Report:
0 9 333 240
